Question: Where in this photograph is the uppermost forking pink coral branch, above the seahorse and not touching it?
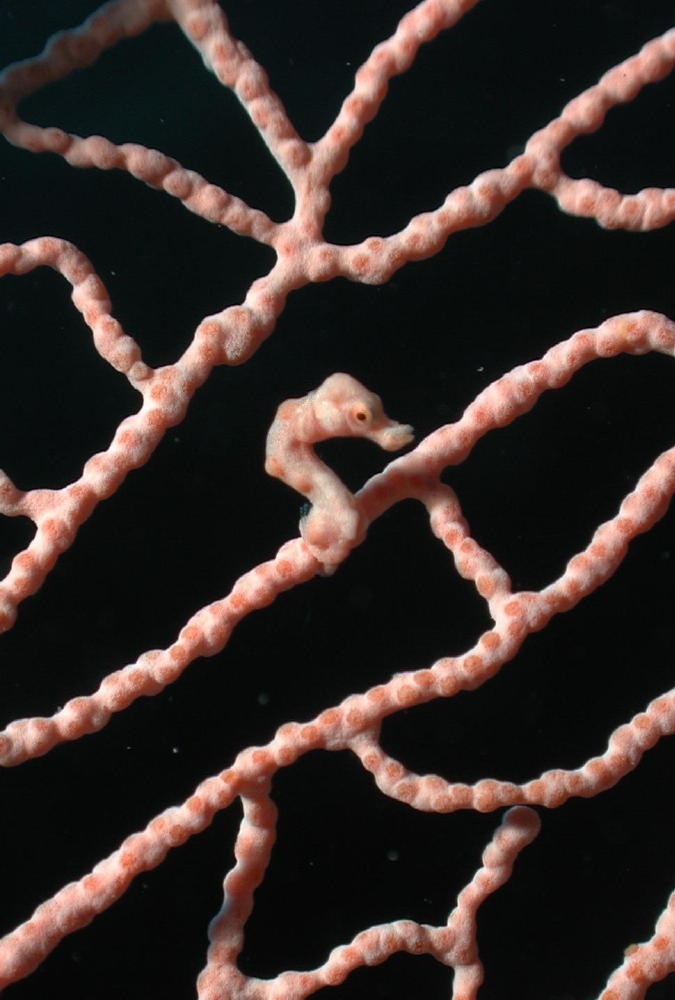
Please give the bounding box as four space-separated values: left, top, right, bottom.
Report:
0 0 675 629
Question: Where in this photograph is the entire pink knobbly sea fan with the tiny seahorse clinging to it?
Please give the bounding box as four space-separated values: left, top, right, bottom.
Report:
0 0 675 1000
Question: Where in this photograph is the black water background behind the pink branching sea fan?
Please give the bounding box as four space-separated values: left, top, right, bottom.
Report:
0 0 675 1000
